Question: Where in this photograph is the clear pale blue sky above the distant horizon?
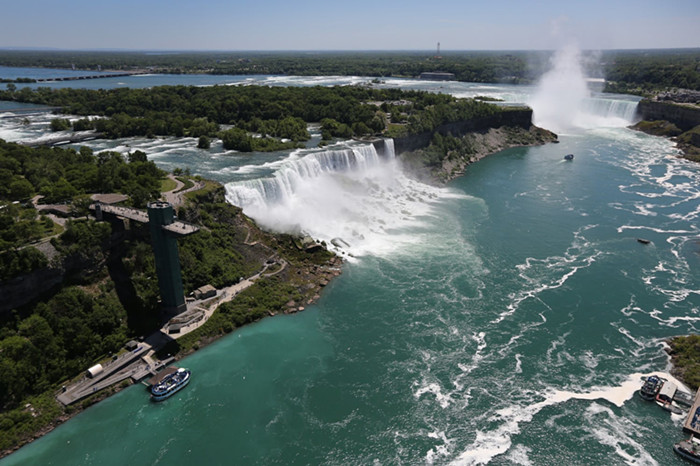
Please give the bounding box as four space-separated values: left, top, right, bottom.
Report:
0 0 700 51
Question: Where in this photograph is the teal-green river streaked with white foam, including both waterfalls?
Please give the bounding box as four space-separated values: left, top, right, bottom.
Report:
0 57 700 466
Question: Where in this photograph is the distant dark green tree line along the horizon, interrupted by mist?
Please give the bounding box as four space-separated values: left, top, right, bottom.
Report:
0 48 700 92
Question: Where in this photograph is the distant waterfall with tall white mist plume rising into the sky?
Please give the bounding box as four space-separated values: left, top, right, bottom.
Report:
528 46 637 132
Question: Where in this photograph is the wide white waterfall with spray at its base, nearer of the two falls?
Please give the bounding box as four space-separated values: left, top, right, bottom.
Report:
226 140 449 256
